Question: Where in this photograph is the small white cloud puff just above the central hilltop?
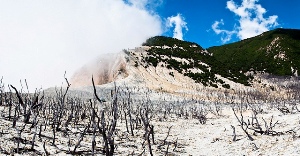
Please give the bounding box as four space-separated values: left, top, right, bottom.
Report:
167 14 188 40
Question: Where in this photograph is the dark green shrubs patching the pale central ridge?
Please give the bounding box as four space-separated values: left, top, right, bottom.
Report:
143 36 250 88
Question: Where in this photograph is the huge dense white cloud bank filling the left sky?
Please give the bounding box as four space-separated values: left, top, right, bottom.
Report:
0 0 162 90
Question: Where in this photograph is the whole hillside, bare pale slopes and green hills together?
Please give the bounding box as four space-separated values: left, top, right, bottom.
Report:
71 29 300 100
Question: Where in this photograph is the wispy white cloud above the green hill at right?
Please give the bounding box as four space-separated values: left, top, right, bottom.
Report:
213 0 278 42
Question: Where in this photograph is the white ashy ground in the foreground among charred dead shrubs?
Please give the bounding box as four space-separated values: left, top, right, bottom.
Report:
0 98 300 155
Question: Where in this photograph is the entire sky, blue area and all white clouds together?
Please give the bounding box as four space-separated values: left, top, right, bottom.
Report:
0 0 300 90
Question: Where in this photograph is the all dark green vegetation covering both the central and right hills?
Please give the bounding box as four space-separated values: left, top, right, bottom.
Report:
143 29 300 88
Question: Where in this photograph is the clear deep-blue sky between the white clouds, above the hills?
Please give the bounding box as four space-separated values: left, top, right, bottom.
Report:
156 0 300 48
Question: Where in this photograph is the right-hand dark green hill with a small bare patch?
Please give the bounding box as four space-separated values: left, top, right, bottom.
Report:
208 29 300 76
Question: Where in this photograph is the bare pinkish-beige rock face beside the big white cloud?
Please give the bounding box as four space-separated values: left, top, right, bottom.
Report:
71 53 128 87
